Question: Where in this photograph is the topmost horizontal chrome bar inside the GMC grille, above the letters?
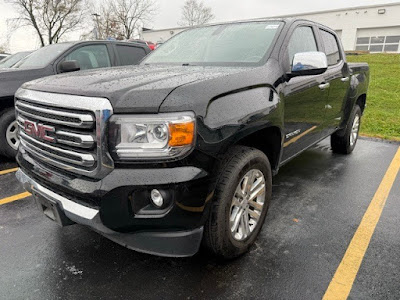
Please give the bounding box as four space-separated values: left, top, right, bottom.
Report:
15 100 94 128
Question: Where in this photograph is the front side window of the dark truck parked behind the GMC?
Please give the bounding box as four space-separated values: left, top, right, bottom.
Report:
64 45 111 70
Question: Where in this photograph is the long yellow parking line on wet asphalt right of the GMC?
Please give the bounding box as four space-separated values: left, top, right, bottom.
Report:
323 147 400 300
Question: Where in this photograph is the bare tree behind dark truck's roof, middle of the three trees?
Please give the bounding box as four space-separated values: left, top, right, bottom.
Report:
103 0 157 40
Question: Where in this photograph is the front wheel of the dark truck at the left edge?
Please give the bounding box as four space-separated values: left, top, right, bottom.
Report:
0 108 19 158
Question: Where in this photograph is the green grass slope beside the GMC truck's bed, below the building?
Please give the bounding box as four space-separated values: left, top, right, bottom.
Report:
347 54 400 141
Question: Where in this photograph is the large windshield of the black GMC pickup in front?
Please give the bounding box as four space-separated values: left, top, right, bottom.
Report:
142 21 282 65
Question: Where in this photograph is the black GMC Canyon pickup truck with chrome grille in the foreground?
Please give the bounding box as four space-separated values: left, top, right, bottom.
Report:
15 19 369 258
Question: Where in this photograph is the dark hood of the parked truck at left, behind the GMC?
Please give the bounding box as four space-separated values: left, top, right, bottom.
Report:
0 68 52 97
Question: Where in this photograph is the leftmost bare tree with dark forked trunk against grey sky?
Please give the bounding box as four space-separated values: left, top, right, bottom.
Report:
8 0 87 46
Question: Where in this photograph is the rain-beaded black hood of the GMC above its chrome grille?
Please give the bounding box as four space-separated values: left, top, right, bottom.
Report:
24 65 248 113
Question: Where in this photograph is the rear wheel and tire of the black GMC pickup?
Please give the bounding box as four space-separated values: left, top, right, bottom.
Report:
331 105 361 154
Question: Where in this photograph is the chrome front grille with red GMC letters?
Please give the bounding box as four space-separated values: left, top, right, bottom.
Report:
15 90 113 178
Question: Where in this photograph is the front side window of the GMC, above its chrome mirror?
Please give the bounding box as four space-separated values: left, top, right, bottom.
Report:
288 26 318 65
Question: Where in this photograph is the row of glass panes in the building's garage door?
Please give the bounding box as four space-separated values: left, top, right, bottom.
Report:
356 35 400 52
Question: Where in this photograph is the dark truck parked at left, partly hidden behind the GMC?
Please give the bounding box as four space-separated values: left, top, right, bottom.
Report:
0 41 150 157
